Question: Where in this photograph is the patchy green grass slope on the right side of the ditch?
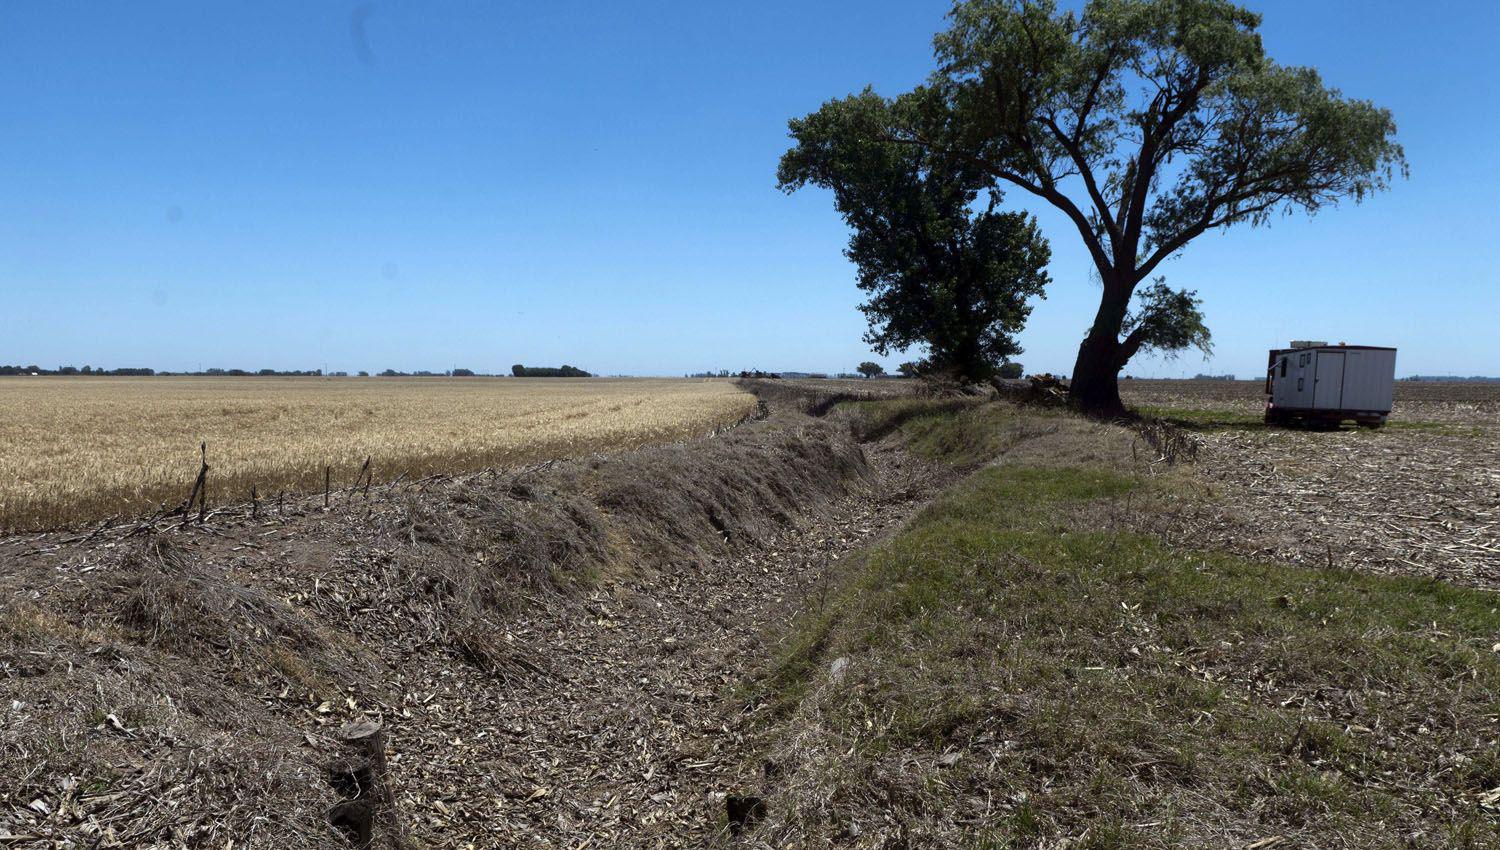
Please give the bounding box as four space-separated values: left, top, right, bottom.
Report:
741 402 1500 847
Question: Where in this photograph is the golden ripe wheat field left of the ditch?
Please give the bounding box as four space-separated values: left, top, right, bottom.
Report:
0 378 756 529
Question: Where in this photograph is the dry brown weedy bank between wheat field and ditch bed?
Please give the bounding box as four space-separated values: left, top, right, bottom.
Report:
0 389 869 847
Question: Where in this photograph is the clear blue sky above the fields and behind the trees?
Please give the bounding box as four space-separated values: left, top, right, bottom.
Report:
0 0 1500 376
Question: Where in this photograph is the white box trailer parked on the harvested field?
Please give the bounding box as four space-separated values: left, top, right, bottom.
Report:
1266 342 1397 427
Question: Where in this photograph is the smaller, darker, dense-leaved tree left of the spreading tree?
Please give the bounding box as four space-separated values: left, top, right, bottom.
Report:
777 90 1052 381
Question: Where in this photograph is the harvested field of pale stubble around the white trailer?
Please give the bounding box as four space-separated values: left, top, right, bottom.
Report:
1122 381 1500 589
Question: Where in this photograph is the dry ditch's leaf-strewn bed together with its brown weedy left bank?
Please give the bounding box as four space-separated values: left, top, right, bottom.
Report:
0 389 933 847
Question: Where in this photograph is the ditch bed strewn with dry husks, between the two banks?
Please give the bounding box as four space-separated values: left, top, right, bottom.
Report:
393 434 947 849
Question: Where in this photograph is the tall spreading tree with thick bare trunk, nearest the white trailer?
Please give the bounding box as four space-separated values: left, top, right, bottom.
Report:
816 0 1406 412
